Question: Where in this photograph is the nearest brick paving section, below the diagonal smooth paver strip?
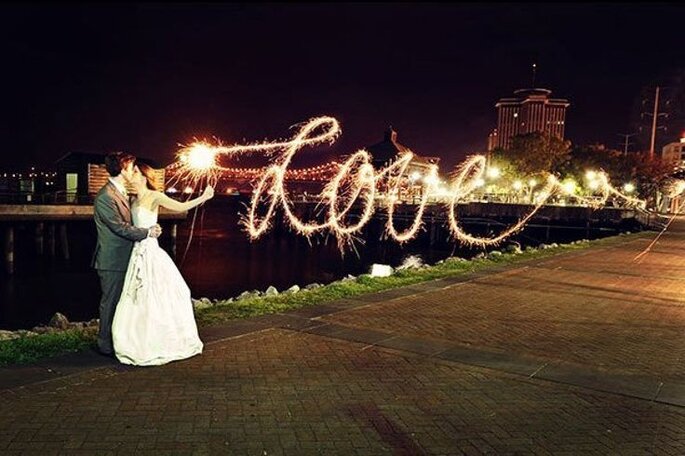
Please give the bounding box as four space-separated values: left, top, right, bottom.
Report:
0 329 685 455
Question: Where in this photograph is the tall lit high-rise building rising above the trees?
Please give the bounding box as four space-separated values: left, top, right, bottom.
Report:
488 89 570 150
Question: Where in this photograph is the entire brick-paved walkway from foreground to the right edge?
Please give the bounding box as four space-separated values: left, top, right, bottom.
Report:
0 221 685 455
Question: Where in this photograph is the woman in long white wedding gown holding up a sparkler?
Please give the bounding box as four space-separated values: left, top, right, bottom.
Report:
112 162 214 366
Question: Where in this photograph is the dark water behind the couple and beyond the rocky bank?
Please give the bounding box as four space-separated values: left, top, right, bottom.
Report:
0 196 632 329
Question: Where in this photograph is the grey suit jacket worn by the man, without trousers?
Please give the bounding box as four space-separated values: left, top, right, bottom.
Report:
92 182 148 271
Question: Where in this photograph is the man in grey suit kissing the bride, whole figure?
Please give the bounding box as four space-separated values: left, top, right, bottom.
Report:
92 152 162 356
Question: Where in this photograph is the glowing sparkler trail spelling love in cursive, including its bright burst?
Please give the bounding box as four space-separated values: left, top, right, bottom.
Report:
174 116 644 249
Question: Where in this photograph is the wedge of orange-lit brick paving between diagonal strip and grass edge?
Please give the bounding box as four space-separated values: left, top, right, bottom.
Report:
322 228 685 381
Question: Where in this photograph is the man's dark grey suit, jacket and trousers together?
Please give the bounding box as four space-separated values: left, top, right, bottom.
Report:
92 181 148 353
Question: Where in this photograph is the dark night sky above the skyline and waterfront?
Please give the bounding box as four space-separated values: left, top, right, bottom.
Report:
0 3 685 170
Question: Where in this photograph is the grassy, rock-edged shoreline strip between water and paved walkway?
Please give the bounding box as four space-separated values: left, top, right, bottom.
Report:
0 231 648 366
